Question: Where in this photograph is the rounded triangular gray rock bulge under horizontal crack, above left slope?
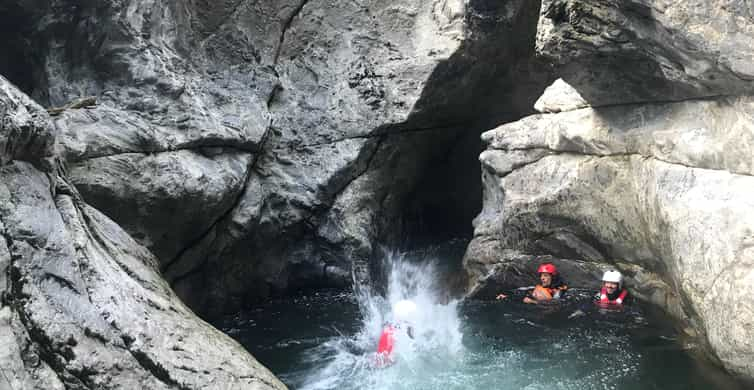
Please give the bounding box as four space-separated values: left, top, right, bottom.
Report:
68 149 253 264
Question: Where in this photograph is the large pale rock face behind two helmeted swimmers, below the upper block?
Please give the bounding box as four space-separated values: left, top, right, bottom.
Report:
466 97 754 376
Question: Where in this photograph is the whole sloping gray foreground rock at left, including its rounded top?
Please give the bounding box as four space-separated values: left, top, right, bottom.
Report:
0 78 285 389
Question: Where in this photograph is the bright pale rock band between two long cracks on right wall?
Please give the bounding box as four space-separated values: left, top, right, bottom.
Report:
482 96 754 175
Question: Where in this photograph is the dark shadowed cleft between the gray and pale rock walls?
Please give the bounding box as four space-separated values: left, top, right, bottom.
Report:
398 0 553 251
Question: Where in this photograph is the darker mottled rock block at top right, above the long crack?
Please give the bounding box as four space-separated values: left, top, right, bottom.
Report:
537 0 754 106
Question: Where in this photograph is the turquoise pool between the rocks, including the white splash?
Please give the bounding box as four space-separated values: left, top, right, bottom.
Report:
217 251 743 390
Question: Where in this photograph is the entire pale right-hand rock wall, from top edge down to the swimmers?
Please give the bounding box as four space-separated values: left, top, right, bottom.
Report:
464 0 754 380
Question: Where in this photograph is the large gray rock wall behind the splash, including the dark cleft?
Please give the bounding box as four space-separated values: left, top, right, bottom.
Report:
0 0 546 314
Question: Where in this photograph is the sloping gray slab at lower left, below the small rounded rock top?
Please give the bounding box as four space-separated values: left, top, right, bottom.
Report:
0 163 284 388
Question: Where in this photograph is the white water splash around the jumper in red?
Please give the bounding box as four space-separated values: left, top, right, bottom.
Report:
296 253 464 390
